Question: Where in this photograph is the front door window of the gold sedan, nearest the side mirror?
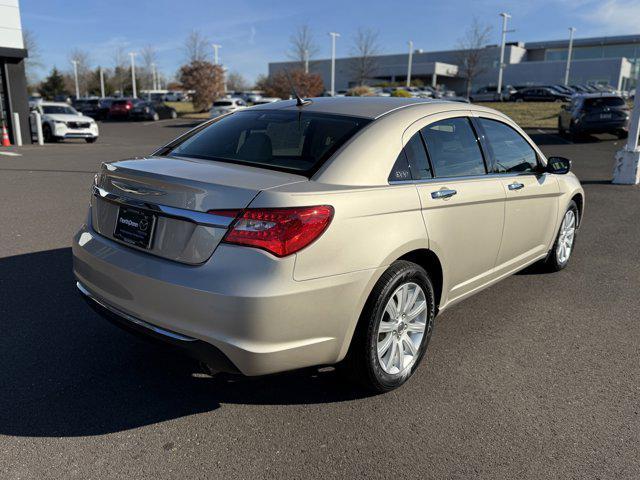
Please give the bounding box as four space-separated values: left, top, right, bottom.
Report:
479 118 538 173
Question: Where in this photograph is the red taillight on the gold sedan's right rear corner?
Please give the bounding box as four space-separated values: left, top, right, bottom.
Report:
209 205 333 257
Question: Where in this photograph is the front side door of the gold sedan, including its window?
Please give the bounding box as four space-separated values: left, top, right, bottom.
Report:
474 113 560 272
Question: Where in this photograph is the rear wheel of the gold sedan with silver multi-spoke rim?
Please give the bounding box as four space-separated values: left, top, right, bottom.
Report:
347 260 435 392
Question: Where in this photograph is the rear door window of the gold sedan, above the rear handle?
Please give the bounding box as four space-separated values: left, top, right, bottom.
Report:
421 117 486 177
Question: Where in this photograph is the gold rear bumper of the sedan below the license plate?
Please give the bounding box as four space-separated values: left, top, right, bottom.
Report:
73 220 383 375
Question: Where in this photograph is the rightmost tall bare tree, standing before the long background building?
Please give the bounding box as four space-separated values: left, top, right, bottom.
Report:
456 18 491 97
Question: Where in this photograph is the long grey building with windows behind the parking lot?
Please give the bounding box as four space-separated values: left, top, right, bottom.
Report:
269 35 640 93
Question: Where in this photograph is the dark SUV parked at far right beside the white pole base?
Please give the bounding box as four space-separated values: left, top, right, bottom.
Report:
558 93 629 139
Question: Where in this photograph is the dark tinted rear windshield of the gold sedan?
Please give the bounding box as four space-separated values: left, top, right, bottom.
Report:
161 110 371 175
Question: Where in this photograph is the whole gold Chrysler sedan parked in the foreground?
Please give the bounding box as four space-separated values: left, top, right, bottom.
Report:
73 97 584 391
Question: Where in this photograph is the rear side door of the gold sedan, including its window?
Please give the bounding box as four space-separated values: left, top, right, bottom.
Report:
405 112 505 303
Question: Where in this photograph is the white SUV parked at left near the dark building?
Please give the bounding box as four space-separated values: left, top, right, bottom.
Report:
34 102 100 143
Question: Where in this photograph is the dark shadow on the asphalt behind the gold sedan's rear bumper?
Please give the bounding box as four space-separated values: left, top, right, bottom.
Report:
0 248 364 437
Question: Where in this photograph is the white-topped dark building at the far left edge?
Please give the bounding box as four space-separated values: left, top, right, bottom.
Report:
0 0 30 144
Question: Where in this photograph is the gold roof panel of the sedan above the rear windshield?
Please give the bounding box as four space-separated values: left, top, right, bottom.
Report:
252 97 462 119
